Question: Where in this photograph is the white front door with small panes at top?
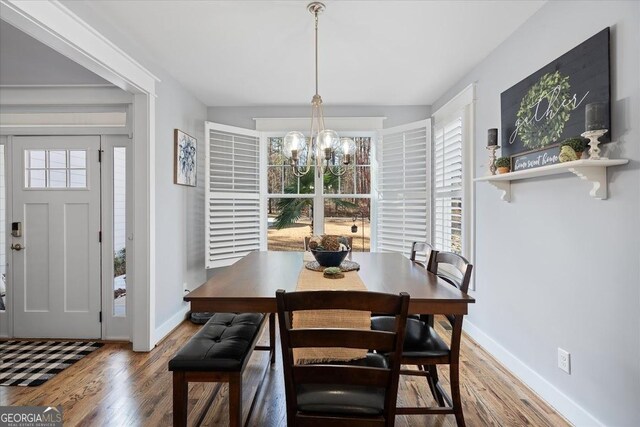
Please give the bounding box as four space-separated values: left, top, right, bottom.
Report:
8 136 101 338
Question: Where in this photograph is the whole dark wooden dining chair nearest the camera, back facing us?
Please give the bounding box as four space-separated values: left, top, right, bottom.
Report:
276 290 409 427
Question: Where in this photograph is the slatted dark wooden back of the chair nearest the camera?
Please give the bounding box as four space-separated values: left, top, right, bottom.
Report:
276 290 409 427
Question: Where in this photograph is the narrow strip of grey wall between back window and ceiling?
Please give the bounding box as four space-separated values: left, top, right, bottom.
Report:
207 105 431 131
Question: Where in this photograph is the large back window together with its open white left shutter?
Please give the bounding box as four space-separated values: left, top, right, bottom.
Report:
205 117 384 268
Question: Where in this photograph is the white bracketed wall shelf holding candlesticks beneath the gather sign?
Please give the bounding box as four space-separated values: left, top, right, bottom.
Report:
474 159 629 202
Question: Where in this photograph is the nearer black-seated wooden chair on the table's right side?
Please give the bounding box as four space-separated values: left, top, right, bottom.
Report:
371 252 473 426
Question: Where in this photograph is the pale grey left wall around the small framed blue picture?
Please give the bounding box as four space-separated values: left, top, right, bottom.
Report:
62 1 207 340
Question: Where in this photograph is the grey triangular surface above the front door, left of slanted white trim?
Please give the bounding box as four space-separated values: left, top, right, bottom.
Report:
0 20 109 86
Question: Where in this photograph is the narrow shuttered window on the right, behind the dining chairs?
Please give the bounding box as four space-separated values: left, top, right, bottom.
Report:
433 85 474 280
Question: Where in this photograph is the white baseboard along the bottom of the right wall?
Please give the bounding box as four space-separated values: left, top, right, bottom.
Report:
463 319 604 427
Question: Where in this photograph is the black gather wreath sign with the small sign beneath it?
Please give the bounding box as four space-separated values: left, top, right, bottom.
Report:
500 27 611 172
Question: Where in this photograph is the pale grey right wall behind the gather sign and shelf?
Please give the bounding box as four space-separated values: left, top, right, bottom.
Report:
433 1 640 426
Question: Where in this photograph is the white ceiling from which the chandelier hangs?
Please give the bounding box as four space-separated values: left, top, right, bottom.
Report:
11 0 544 106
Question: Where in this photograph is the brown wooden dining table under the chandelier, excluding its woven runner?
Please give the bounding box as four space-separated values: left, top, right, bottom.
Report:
184 251 475 314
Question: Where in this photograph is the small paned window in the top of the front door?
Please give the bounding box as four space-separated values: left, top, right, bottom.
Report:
24 150 87 188
